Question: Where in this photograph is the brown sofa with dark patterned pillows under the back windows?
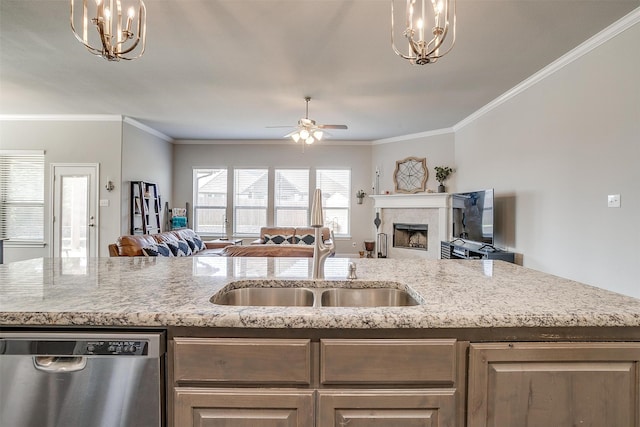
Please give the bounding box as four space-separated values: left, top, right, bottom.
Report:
222 227 334 257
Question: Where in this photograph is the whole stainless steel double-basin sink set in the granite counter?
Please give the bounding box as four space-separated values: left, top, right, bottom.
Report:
210 281 419 307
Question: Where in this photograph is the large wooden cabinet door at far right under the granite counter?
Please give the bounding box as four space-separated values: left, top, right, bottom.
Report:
468 343 640 427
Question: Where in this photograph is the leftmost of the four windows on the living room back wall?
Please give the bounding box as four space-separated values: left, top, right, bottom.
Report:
193 169 227 234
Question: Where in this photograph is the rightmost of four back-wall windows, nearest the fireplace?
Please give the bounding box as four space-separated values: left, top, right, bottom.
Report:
316 169 351 236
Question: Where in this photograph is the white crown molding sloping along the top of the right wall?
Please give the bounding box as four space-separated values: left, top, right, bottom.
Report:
453 7 640 132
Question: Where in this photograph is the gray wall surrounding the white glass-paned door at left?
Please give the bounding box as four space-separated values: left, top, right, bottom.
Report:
0 116 122 262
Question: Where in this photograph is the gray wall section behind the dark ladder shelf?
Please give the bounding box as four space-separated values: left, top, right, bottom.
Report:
121 120 173 236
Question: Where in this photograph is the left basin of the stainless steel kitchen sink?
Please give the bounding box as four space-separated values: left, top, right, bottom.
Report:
211 288 314 307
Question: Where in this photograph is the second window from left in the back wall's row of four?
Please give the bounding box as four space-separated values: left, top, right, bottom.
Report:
233 169 269 235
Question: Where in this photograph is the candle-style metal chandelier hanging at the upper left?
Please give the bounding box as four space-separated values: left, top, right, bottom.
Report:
70 0 147 61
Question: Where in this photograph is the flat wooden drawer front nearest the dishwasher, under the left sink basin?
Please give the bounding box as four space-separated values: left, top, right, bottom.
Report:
173 338 311 385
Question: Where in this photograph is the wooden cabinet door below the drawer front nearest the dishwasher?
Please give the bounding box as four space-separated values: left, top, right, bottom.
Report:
174 388 314 427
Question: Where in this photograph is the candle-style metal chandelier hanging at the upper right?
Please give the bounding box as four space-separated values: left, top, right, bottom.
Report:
391 0 456 65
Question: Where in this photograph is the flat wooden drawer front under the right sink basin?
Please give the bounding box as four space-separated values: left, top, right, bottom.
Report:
320 339 456 385
